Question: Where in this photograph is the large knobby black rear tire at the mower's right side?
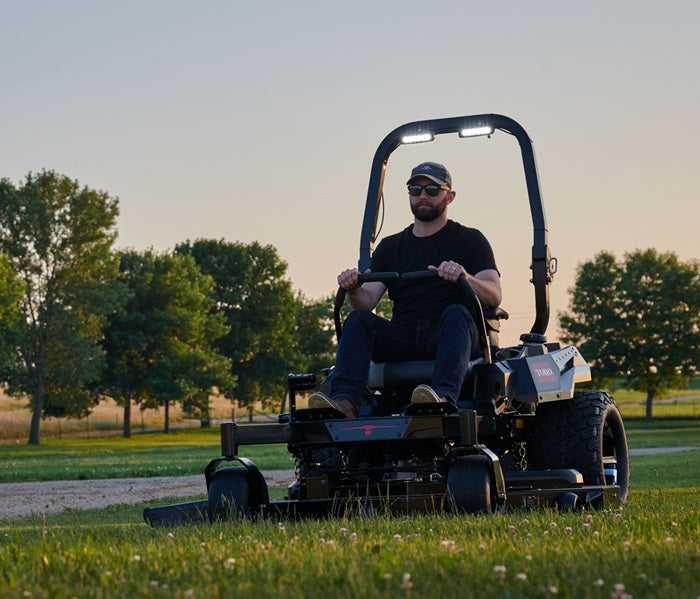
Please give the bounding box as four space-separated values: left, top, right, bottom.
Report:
528 391 629 504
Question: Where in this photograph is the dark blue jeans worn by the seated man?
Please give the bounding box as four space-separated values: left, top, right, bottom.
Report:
330 304 480 407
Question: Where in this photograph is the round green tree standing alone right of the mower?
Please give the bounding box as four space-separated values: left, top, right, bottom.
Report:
559 249 700 420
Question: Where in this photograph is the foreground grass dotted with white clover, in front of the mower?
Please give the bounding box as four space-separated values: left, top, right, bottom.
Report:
0 489 700 599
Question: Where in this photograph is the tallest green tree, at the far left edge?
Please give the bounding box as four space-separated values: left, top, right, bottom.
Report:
0 171 122 445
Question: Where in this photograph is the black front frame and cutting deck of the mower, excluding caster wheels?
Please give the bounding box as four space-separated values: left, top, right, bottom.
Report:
143 410 621 526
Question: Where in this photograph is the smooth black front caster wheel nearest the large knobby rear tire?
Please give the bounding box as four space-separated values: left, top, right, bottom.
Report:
447 455 496 514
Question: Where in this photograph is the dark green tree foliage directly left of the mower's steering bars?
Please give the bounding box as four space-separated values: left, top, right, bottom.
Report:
176 240 331 414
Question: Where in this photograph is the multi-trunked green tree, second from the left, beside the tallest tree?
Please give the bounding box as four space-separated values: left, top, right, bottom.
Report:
102 251 233 437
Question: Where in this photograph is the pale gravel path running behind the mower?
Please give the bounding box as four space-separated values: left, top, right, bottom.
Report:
0 447 700 520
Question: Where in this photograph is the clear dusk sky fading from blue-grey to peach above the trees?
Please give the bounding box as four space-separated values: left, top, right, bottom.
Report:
0 0 700 345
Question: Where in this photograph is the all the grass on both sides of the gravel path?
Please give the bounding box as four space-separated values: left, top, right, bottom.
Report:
0 397 700 599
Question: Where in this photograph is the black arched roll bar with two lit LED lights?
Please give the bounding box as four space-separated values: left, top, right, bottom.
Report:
358 114 556 335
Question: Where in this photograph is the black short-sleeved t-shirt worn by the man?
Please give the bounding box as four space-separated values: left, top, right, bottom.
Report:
370 220 498 323
